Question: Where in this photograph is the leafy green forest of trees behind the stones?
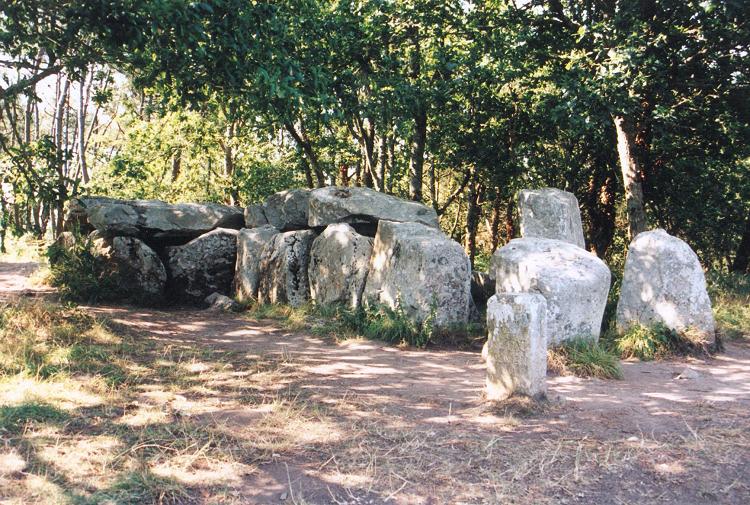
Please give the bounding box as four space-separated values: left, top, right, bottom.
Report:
0 0 750 272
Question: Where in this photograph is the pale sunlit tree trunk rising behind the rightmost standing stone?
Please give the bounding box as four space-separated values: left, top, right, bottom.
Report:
613 116 647 239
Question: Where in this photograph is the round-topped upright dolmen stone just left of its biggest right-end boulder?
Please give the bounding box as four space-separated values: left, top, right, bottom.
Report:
308 223 372 308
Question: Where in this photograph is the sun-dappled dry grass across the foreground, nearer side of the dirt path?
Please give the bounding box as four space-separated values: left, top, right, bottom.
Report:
0 298 750 504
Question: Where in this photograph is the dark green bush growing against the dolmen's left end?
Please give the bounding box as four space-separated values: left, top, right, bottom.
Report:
47 236 122 303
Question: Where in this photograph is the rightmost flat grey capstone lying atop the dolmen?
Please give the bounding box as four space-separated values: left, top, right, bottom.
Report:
308 186 438 228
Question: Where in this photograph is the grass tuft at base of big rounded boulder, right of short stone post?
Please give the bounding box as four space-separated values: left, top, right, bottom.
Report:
547 338 622 379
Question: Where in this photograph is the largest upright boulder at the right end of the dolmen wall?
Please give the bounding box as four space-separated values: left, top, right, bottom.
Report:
364 221 471 327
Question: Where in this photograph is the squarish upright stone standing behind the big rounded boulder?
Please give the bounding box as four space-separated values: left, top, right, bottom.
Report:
518 188 586 248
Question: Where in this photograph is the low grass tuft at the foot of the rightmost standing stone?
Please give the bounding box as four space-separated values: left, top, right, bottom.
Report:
615 323 707 361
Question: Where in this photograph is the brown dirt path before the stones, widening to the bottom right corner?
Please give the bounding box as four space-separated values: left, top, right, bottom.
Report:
0 265 750 504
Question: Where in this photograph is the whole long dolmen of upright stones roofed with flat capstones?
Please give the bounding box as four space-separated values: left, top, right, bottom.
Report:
67 187 474 328
